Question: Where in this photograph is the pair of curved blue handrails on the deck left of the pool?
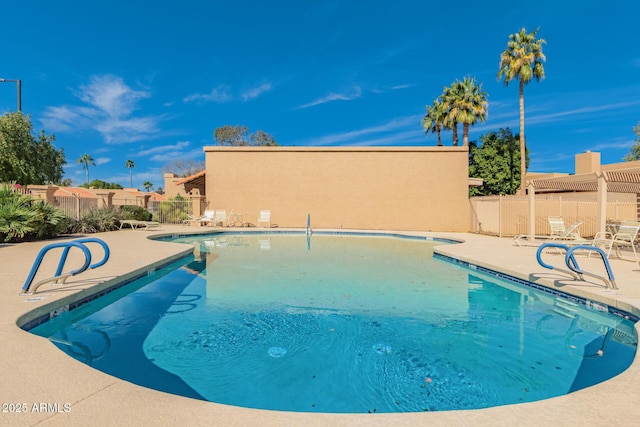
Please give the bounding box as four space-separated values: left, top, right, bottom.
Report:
20 237 111 295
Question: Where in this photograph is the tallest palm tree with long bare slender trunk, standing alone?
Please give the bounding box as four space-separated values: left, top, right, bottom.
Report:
498 28 547 194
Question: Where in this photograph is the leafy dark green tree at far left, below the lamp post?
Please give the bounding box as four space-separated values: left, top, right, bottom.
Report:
0 112 66 184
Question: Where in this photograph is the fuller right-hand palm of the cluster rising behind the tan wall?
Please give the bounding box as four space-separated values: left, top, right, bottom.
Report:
453 77 488 146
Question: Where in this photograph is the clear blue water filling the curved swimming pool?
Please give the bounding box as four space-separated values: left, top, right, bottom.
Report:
31 234 637 413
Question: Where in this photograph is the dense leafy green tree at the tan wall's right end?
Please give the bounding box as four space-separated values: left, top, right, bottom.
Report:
469 128 529 196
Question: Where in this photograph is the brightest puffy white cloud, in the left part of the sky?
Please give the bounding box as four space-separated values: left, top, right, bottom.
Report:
41 74 161 144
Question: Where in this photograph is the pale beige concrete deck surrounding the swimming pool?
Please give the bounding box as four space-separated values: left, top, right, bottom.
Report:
0 225 640 426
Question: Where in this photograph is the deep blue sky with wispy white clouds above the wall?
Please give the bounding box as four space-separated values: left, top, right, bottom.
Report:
0 0 640 188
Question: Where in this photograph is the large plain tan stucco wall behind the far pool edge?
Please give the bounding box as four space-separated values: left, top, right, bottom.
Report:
205 147 469 231
